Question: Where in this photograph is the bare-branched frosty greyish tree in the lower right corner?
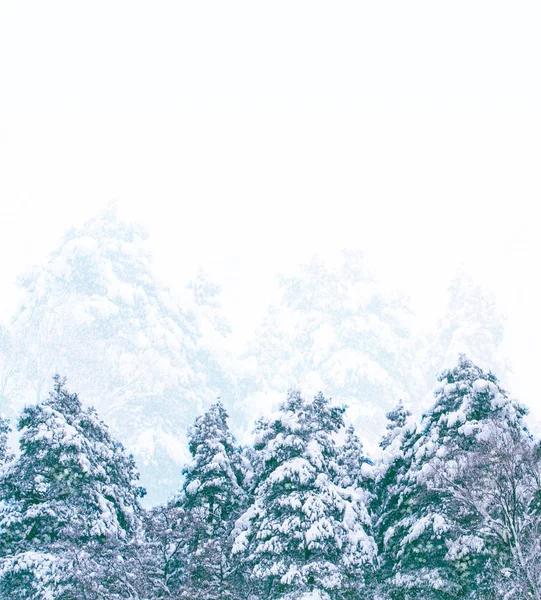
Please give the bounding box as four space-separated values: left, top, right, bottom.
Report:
430 406 541 600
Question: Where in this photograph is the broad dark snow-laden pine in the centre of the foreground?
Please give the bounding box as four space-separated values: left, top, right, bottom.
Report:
235 392 374 600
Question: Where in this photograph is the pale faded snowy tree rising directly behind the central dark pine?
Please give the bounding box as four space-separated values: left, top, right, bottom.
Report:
238 252 420 454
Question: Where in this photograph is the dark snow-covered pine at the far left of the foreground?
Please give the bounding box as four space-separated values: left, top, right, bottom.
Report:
0 376 143 600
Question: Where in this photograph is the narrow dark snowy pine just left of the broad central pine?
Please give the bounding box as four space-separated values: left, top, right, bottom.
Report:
174 402 244 600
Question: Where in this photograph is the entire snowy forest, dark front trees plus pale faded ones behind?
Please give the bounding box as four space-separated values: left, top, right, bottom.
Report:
0 205 541 600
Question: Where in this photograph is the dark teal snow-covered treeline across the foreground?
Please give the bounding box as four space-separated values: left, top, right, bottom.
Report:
0 355 541 600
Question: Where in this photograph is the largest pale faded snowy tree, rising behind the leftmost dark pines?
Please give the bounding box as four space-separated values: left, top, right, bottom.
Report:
6 205 229 502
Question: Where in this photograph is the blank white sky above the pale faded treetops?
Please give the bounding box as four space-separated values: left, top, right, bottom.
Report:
0 0 541 417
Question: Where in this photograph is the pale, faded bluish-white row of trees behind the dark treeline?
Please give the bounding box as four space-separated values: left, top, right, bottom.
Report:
0 206 506 505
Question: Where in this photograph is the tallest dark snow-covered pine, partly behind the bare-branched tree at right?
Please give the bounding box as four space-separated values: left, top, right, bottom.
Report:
380 355 525 599
